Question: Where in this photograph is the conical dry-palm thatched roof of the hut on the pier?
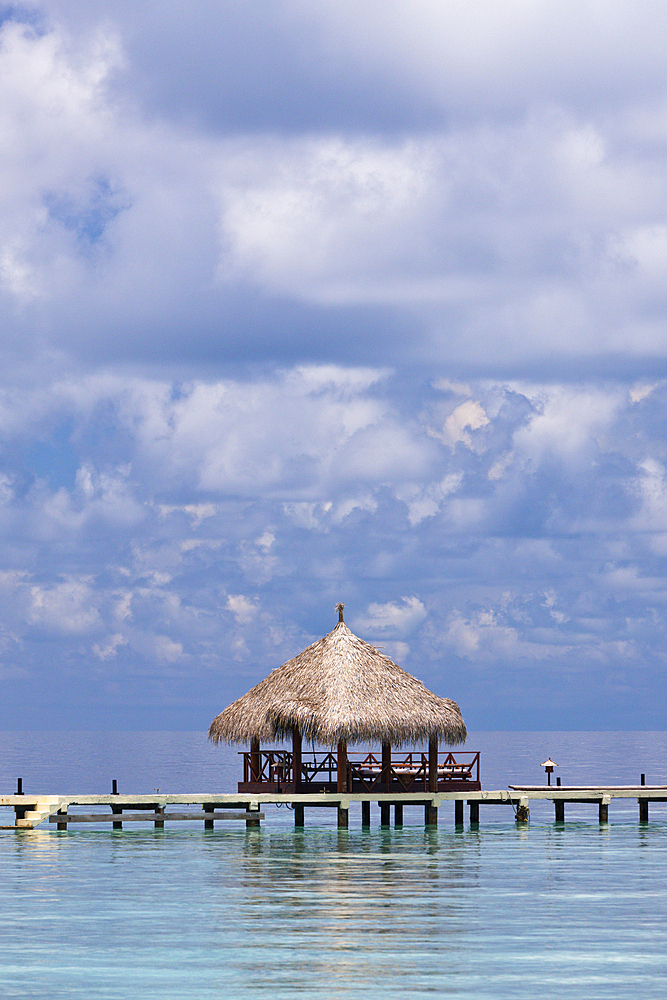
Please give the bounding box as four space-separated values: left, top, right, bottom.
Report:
208 606 466 746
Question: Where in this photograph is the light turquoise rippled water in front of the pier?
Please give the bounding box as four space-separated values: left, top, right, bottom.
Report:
0 823 667 1000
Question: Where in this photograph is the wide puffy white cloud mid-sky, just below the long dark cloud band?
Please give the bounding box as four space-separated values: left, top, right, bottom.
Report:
100 366 434 498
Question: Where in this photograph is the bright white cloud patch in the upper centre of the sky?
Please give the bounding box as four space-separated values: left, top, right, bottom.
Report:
214 138 432 301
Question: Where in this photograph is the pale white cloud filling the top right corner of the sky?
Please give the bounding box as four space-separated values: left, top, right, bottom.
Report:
299 0 665 117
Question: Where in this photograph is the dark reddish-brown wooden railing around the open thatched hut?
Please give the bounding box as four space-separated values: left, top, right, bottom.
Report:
241 750 480 792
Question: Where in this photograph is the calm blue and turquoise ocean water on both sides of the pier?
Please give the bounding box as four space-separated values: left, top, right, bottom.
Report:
0 733 667 1000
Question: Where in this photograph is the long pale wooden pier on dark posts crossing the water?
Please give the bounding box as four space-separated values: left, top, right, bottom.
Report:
0 785 667 830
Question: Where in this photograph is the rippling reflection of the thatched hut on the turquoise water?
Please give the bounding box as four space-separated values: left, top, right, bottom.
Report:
226 827 480 995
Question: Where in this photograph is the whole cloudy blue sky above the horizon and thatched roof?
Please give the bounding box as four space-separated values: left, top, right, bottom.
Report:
0 0 667 730
